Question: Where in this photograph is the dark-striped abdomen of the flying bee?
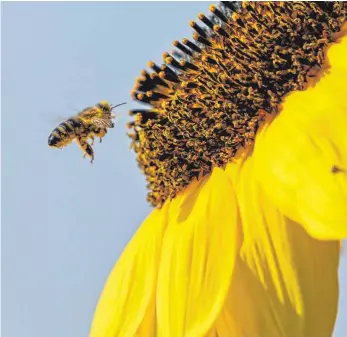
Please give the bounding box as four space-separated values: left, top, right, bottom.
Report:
48 118 84 148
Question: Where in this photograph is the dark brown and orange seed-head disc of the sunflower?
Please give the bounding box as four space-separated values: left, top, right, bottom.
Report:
128 1 347 207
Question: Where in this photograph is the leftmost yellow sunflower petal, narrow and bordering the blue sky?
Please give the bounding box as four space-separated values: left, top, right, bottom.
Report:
90 204 167 337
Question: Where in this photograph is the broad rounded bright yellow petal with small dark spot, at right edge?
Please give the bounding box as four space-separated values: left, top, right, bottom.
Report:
253 32 347 240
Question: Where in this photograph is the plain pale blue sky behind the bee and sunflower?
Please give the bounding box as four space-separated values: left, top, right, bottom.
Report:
1 2 347 337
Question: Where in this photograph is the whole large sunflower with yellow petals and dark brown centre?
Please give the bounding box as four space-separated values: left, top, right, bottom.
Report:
90 2 347 337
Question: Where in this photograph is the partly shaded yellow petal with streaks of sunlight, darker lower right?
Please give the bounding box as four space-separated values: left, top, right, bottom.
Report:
220 157 339 337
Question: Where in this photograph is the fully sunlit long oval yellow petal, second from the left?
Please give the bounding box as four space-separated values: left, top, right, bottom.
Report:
157 168 240 337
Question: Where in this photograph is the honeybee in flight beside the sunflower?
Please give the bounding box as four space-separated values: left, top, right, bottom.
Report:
48 101 126 163
